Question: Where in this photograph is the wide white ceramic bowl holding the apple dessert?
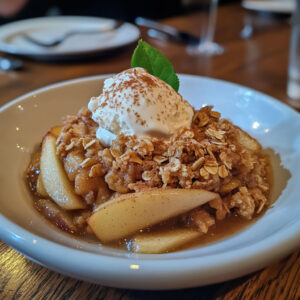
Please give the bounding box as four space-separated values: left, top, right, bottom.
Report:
0 75 300 289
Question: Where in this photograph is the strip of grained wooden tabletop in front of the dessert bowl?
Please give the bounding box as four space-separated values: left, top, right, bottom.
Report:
0 243 300 300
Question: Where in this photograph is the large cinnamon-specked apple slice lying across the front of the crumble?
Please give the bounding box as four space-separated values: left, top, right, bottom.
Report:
88 189 219 243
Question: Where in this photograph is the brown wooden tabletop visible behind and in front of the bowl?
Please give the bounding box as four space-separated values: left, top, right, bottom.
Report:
0 4 300 300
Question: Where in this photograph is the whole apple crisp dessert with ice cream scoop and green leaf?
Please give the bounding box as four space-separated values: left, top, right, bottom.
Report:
26 41 271 253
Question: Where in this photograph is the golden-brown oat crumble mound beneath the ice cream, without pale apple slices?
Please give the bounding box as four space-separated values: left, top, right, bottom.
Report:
52 106 270 232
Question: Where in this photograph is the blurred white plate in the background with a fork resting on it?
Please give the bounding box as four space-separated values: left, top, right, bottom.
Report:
0 16 140 60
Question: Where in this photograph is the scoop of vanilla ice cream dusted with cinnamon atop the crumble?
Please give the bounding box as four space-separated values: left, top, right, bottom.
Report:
88 68 194 146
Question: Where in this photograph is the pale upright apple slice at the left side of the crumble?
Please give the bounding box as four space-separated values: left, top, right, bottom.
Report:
40 132 86 209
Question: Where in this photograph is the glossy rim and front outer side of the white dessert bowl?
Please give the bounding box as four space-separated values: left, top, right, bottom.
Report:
0 74 300 289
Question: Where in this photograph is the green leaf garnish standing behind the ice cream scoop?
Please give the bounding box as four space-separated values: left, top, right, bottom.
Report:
131 40 179 92
